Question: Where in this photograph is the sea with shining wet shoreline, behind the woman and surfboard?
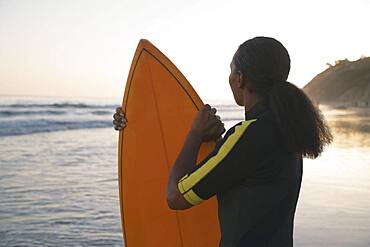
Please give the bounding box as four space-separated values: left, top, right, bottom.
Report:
0 96 370 247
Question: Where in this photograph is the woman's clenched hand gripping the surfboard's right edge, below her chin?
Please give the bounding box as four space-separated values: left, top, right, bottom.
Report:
190 104 225 141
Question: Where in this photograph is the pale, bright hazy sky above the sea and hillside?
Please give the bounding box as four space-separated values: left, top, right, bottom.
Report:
0 0 370 100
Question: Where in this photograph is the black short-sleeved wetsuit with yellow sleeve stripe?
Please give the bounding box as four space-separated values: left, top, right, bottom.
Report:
178 102 302 247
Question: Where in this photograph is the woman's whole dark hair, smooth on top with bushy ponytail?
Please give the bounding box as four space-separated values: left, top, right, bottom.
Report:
233 37 333 158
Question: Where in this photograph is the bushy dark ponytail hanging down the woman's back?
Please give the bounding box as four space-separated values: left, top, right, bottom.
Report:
267 81 333 158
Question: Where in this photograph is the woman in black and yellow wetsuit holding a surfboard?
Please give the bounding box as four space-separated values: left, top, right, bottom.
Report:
114 37 332 247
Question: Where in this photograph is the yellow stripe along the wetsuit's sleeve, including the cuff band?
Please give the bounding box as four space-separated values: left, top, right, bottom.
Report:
177 119 256 205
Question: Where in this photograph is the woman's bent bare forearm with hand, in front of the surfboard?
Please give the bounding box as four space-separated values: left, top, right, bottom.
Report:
167 105 225 210
